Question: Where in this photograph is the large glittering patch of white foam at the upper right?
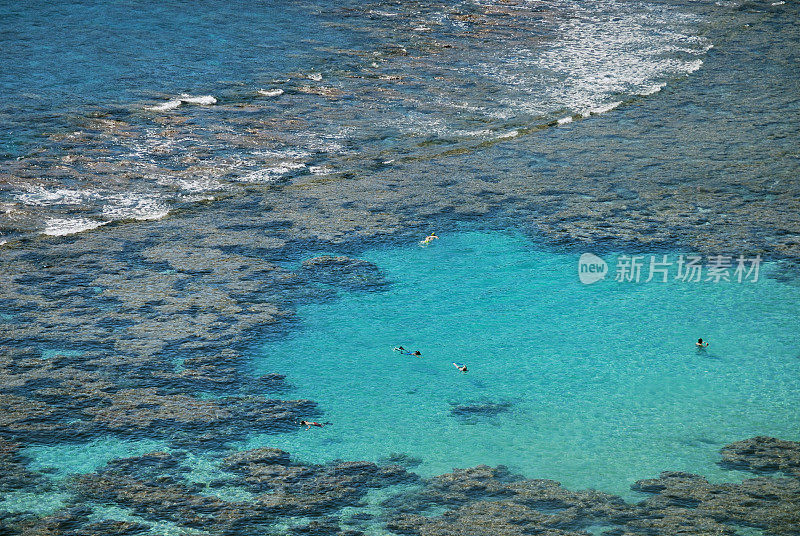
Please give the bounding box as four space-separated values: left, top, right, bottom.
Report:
478 0 712 121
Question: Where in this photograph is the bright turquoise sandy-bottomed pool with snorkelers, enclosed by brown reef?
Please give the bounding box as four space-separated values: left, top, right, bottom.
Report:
253 232 800 495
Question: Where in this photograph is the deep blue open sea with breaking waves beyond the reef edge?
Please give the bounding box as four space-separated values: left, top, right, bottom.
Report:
0 0 713 237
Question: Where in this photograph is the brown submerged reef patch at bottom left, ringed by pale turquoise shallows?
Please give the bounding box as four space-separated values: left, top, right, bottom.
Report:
63 448 417 534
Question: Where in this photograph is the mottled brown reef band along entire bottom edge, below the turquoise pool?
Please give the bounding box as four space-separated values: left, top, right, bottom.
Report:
0 437 800 536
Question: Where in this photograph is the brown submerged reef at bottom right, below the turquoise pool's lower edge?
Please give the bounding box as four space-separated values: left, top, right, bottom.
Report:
383 438 800 536
